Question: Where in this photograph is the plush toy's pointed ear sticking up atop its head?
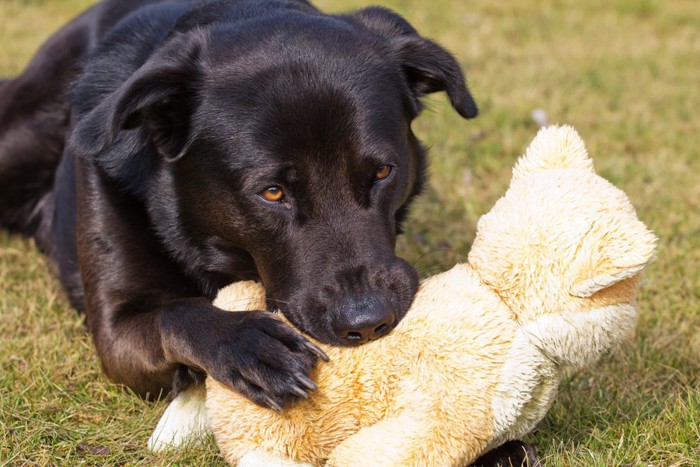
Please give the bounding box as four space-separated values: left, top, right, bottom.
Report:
513 125 595 181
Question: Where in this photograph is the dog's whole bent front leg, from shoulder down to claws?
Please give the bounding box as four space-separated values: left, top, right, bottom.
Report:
77 167 322 409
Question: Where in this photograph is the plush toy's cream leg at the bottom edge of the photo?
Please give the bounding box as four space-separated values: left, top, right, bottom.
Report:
326 411 486 467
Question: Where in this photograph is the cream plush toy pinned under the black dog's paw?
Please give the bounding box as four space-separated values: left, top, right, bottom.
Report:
151 126 656 466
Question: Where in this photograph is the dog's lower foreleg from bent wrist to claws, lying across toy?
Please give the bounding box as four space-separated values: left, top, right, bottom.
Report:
160 299 322 411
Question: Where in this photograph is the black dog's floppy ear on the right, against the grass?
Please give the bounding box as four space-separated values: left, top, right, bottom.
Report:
351 7 478 118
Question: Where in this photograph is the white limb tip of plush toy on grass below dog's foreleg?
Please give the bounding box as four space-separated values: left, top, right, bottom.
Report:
148 385 207 451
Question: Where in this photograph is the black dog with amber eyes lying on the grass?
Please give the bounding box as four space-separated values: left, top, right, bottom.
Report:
0 0 477 409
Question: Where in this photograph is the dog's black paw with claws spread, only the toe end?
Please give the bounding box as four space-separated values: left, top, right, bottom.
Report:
205 311 328 411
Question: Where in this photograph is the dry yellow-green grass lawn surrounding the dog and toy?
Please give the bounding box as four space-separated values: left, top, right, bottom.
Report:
0 0 700 466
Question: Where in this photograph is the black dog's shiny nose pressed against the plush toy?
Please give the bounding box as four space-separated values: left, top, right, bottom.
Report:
333 296 396 345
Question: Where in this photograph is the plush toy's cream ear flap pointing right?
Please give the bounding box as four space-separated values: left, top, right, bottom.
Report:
569 214 657 297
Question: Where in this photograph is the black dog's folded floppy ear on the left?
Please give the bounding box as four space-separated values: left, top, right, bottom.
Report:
71 35 206 162
